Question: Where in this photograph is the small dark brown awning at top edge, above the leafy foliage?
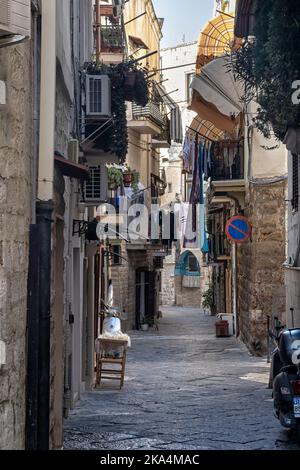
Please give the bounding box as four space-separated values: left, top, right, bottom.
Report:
234 0 257 38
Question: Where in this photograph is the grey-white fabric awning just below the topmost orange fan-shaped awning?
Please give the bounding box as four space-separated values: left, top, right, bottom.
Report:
191 57 244 118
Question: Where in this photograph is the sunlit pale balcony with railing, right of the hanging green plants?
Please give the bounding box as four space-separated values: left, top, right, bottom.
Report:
128 101 165 135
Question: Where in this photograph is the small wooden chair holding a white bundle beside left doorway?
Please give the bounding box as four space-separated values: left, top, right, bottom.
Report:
96 338 127 390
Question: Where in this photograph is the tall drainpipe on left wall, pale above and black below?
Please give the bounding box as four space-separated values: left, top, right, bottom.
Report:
36 0 56 450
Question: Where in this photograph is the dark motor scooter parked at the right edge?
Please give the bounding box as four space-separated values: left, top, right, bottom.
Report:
269 318 300 445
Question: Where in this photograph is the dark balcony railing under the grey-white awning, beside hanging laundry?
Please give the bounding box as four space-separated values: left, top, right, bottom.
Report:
211 141 245 181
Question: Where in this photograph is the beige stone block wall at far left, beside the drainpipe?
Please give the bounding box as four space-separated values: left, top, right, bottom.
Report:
0 42 32 449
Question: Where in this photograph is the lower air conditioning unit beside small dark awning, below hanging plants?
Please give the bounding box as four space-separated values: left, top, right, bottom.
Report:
82 165 108 205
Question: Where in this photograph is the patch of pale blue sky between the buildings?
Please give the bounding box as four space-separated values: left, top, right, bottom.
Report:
152 0 214 47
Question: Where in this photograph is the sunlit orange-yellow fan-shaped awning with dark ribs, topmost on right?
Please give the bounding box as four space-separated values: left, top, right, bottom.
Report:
196 13 238 73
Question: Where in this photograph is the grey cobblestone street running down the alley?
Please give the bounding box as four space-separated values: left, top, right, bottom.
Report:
65 308 298 450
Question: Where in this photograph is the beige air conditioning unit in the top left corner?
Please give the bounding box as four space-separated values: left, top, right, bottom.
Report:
0 0 31 38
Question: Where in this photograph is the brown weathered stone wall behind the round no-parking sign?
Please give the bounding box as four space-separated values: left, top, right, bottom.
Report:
237 182 286 354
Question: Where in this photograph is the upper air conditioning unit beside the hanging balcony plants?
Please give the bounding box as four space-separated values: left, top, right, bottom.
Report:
86 75 111 119
